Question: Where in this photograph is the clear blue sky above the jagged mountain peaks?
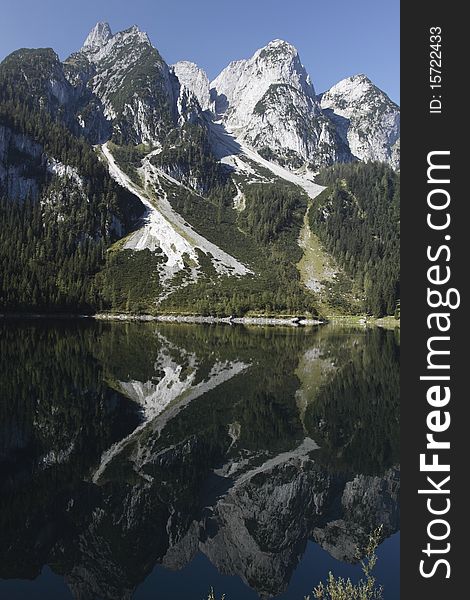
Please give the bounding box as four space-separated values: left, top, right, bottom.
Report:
0 0 400 103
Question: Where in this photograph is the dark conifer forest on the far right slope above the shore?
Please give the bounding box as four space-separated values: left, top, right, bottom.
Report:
309 163 400 317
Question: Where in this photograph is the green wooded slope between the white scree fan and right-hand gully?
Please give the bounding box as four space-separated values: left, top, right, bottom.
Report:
160 178 324 316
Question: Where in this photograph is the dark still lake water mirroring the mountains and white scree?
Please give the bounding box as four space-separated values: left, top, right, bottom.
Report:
0 321 400 600
